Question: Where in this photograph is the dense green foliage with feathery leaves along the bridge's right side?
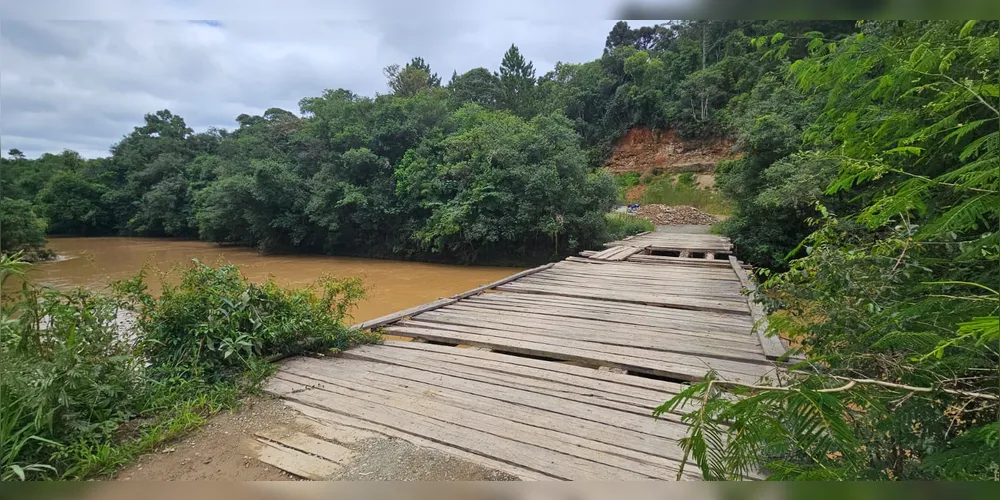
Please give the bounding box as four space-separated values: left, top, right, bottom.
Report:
658 21 1000 480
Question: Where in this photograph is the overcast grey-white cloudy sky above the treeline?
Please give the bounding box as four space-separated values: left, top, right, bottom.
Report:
0 0 688 157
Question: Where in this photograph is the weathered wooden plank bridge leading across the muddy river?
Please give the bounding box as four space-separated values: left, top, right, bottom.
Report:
267 233 786 480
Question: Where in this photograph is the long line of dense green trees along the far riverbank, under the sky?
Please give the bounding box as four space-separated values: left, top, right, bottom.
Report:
0 21 851 262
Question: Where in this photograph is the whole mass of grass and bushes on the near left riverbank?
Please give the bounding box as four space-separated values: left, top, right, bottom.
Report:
0 257 371 479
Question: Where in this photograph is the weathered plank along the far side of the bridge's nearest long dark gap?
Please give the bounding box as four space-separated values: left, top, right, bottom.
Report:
390 325 771 383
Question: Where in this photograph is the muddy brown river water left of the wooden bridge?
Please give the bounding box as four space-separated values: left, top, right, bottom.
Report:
17 238 521 324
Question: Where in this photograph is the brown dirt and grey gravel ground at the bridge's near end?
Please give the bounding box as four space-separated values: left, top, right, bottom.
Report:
116 396 515 481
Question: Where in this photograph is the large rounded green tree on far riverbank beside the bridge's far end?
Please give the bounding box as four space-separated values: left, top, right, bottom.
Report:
396 105 614 262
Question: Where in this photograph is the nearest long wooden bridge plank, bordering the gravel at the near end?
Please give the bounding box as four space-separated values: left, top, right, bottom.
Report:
284 400 556 481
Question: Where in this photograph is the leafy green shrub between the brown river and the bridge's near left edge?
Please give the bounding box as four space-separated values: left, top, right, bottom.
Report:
117 261 364 379
